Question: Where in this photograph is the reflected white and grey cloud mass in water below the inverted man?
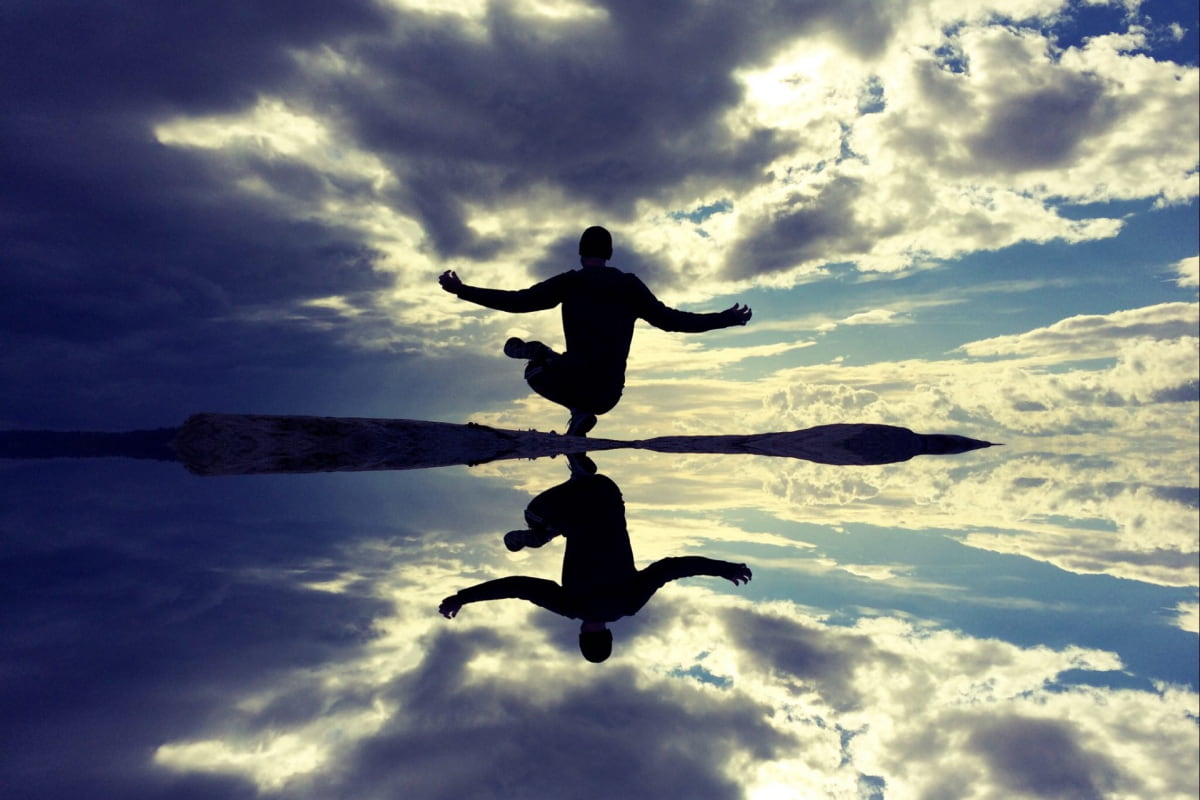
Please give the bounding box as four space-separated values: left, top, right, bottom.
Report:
147 537 1195 798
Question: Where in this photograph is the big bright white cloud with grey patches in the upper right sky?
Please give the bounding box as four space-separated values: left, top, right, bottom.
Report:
705 2 1198 284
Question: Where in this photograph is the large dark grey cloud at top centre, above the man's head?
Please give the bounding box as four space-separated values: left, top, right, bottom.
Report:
314 2 889 254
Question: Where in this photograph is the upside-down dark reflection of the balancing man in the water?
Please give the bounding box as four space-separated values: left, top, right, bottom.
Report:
438 456 750 662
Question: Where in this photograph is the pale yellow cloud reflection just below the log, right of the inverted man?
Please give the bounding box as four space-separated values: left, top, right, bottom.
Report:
480 445 1198 587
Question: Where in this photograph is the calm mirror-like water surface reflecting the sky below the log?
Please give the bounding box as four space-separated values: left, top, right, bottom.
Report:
0 445 1198 798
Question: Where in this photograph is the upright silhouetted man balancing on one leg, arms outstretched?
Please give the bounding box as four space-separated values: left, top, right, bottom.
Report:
438 227 750 437
